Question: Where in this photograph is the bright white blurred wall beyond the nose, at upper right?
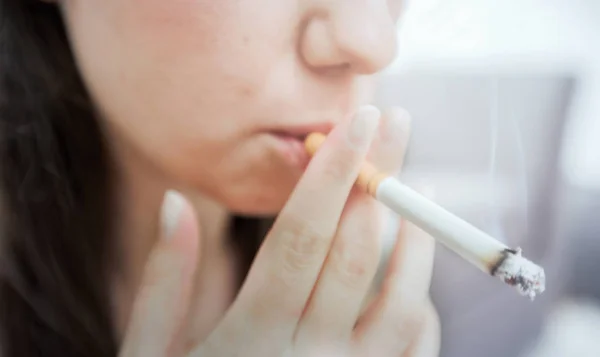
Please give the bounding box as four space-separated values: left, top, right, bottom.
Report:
388 0 600 189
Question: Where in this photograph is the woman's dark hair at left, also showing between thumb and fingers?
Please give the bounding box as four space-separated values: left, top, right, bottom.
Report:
0 0 263 357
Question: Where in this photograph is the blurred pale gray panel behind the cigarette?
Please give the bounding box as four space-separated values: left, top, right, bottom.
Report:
376 72 576 357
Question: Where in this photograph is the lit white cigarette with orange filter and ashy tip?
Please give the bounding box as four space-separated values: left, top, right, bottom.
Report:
305 133 546 300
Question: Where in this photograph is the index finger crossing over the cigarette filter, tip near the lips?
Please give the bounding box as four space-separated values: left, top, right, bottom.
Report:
233 107 380 336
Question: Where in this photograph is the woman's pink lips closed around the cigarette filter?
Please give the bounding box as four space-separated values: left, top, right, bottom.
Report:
267 123 334 169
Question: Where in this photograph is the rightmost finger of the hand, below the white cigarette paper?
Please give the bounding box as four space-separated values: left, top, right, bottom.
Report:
355 186 435 355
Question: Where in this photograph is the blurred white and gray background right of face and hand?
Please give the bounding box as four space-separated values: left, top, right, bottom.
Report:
377 0 600 357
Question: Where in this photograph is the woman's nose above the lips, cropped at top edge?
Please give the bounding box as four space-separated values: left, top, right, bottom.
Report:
300 0 396 74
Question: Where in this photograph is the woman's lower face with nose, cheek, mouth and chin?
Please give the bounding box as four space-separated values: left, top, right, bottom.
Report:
61 0 401 214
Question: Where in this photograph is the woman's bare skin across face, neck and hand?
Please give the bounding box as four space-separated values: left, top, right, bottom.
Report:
58 0 439 357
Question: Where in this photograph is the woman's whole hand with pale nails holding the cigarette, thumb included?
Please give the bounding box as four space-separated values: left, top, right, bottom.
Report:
120 105 439 357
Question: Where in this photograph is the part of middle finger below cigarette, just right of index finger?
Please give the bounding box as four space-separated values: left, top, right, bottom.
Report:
295 186 382 355
